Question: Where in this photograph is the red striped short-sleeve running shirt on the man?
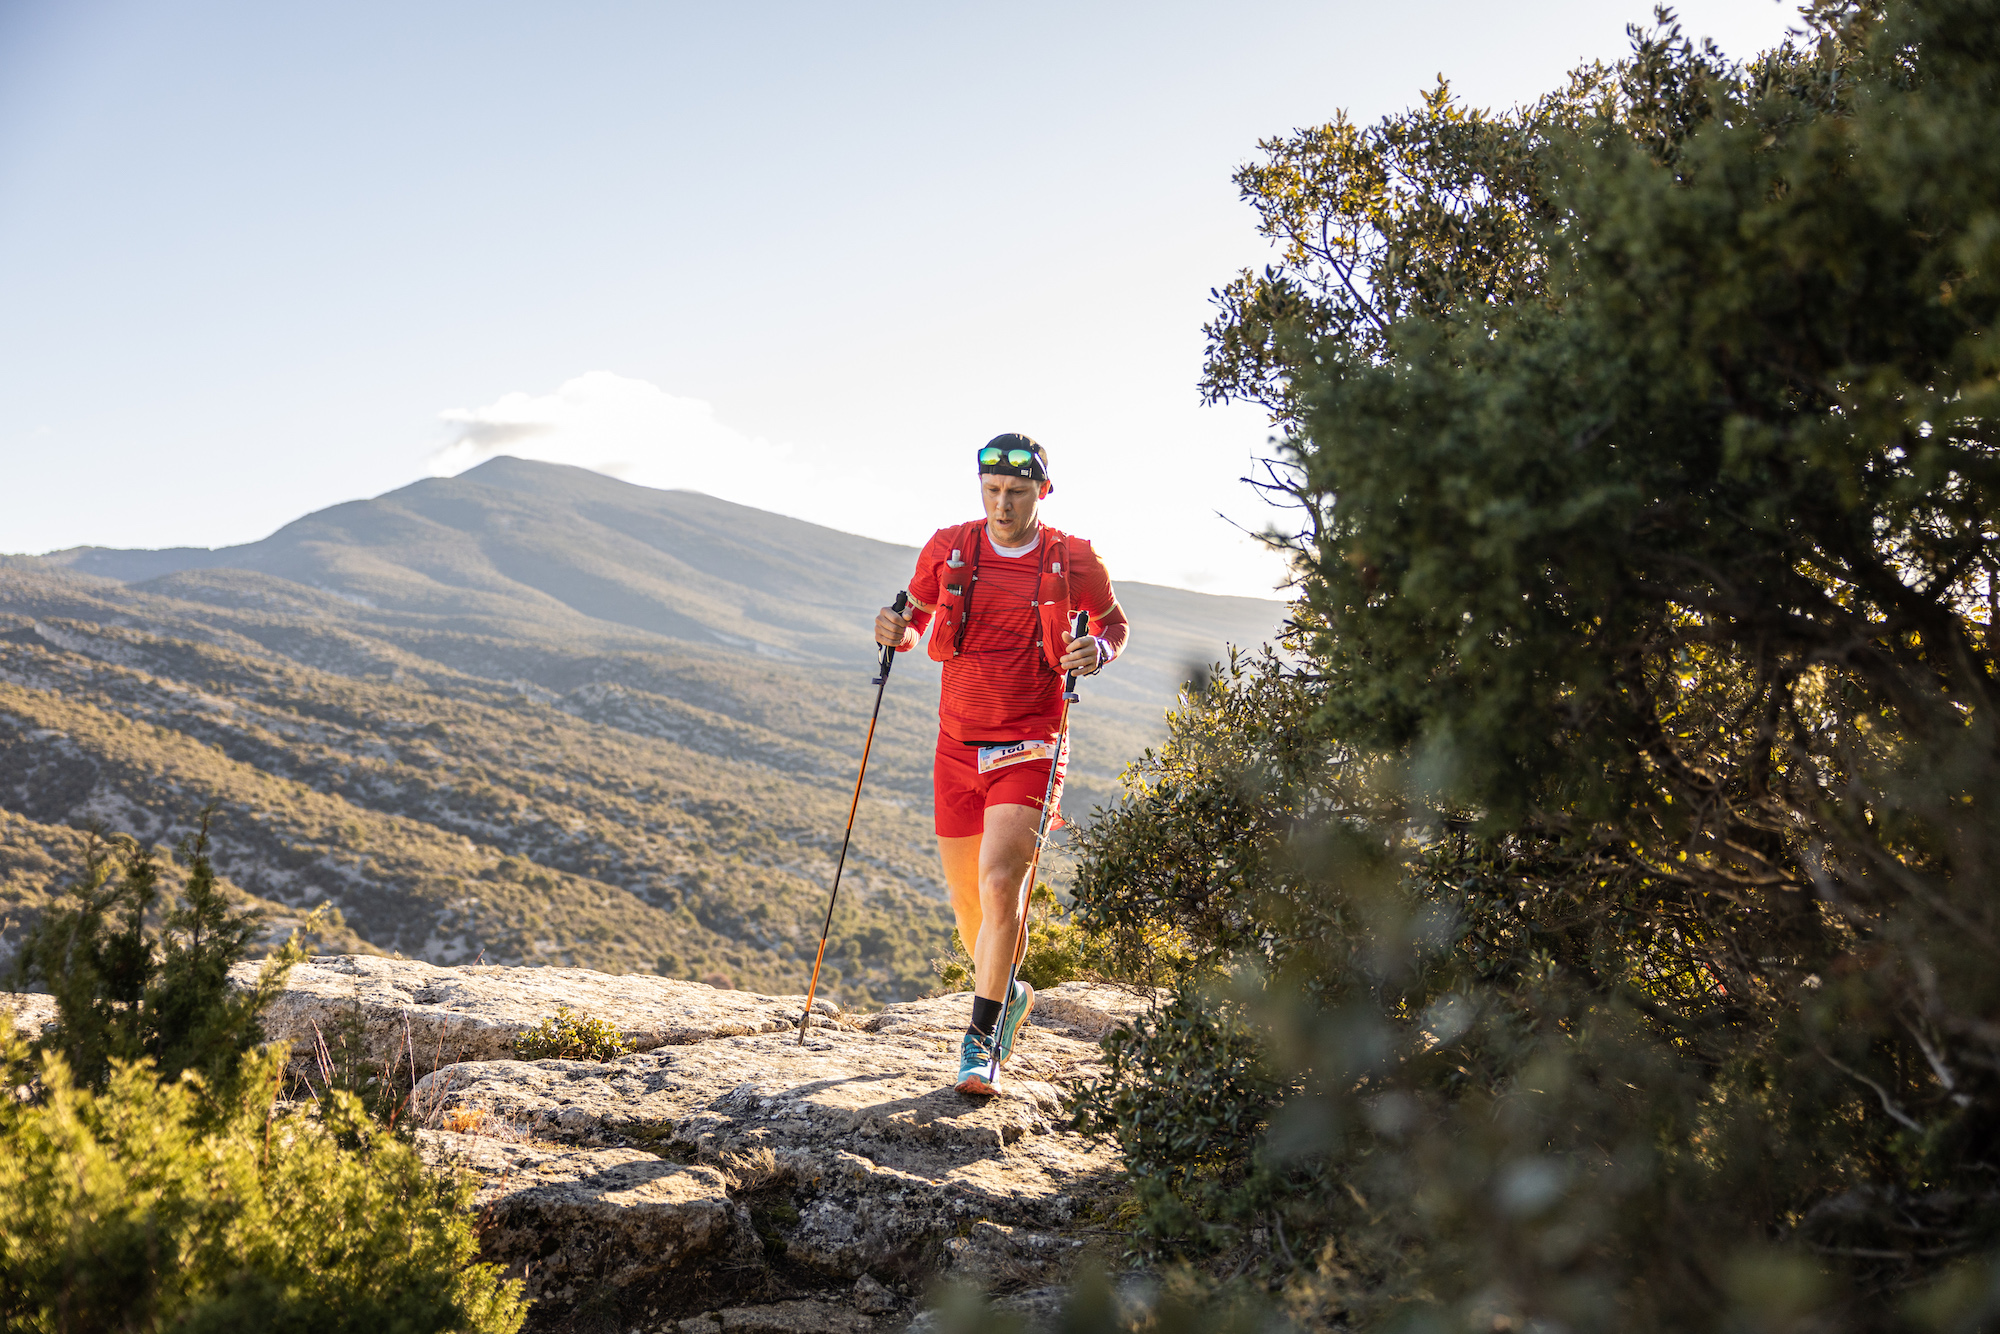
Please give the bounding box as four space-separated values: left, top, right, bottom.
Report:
910 524 1118 744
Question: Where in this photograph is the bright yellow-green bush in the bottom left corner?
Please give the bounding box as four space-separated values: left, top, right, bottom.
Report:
0 1024 524 1334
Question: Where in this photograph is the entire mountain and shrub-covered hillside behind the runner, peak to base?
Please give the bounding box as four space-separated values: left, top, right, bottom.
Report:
0 460 1280 1004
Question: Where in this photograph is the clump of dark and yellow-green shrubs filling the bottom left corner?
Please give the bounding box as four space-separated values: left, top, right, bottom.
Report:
0 818 524 1334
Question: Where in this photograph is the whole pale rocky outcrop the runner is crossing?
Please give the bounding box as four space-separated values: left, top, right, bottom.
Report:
246 958 1148 1334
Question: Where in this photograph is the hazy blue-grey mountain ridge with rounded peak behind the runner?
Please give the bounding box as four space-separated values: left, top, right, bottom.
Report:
36 456 1282 688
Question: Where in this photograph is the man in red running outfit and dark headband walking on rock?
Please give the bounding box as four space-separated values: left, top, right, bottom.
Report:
876 434 1128 1094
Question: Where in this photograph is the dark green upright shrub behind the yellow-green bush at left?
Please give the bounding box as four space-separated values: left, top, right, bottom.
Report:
14 810 300 1086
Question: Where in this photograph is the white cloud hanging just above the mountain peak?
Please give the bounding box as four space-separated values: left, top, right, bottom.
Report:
430 370 810 510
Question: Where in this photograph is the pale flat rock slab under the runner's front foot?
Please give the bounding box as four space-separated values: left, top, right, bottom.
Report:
416 1026 1118 1282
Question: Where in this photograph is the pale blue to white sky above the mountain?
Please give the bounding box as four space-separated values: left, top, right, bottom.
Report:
0 0 1796 594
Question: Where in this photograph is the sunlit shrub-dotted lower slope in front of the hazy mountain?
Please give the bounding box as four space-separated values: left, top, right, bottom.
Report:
0 580 948 1004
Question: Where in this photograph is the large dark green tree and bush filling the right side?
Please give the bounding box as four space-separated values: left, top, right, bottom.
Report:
1078 0 2000 1330
